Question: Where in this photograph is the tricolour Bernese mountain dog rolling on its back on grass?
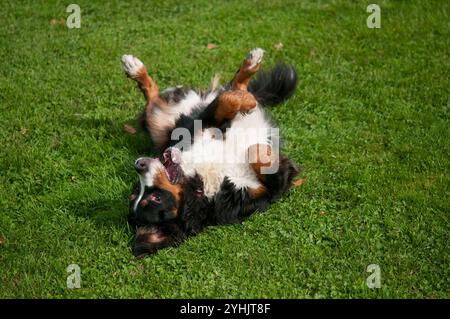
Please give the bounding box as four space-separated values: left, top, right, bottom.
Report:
122 48 298 257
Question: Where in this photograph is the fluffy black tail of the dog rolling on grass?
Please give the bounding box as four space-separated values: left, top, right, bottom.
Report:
248 63 298 106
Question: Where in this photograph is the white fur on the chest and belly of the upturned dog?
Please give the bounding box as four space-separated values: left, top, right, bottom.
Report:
181 107 273 198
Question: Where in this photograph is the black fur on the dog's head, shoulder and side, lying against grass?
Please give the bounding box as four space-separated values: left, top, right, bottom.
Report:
129 157 298 256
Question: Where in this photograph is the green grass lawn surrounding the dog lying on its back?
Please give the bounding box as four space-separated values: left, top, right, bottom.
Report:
0 0 450 298
